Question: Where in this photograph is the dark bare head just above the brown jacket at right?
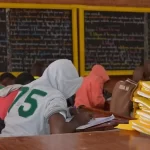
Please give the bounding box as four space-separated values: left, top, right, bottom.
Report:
132 66 144 82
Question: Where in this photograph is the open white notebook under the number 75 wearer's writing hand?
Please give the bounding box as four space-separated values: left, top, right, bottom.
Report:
66 115 115 130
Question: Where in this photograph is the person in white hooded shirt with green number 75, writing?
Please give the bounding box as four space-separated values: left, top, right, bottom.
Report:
1 59 91 136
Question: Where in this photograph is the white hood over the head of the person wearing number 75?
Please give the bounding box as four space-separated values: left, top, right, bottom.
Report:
41 59 83 99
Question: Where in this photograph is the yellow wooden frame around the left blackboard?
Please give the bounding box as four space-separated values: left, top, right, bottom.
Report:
0 3 78 76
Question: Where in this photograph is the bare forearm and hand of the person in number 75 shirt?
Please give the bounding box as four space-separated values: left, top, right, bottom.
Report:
49 112 91 134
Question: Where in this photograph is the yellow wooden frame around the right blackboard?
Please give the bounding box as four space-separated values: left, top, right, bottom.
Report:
79 6 150 76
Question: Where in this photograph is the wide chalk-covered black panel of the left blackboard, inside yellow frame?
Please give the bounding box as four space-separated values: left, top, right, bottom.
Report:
9 9 73 71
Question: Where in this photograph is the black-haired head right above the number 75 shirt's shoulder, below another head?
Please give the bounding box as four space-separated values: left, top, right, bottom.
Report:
15 72 34 85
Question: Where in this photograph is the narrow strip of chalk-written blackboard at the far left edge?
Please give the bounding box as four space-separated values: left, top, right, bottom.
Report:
0 9 7 72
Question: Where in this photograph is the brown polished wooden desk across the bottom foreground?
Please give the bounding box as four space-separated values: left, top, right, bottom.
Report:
0 131 150 150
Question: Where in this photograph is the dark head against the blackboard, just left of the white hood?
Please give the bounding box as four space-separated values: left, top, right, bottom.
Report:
30 62 45 77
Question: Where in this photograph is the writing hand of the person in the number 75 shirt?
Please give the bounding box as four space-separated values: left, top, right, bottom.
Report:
74 111 93 126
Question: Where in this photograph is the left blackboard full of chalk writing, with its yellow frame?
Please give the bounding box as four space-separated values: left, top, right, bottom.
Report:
0 4 78 72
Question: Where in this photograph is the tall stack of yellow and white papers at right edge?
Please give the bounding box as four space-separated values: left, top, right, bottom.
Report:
132 81 150 134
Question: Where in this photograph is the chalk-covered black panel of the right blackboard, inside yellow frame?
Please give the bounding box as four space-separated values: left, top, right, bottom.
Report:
84 11 144 71
